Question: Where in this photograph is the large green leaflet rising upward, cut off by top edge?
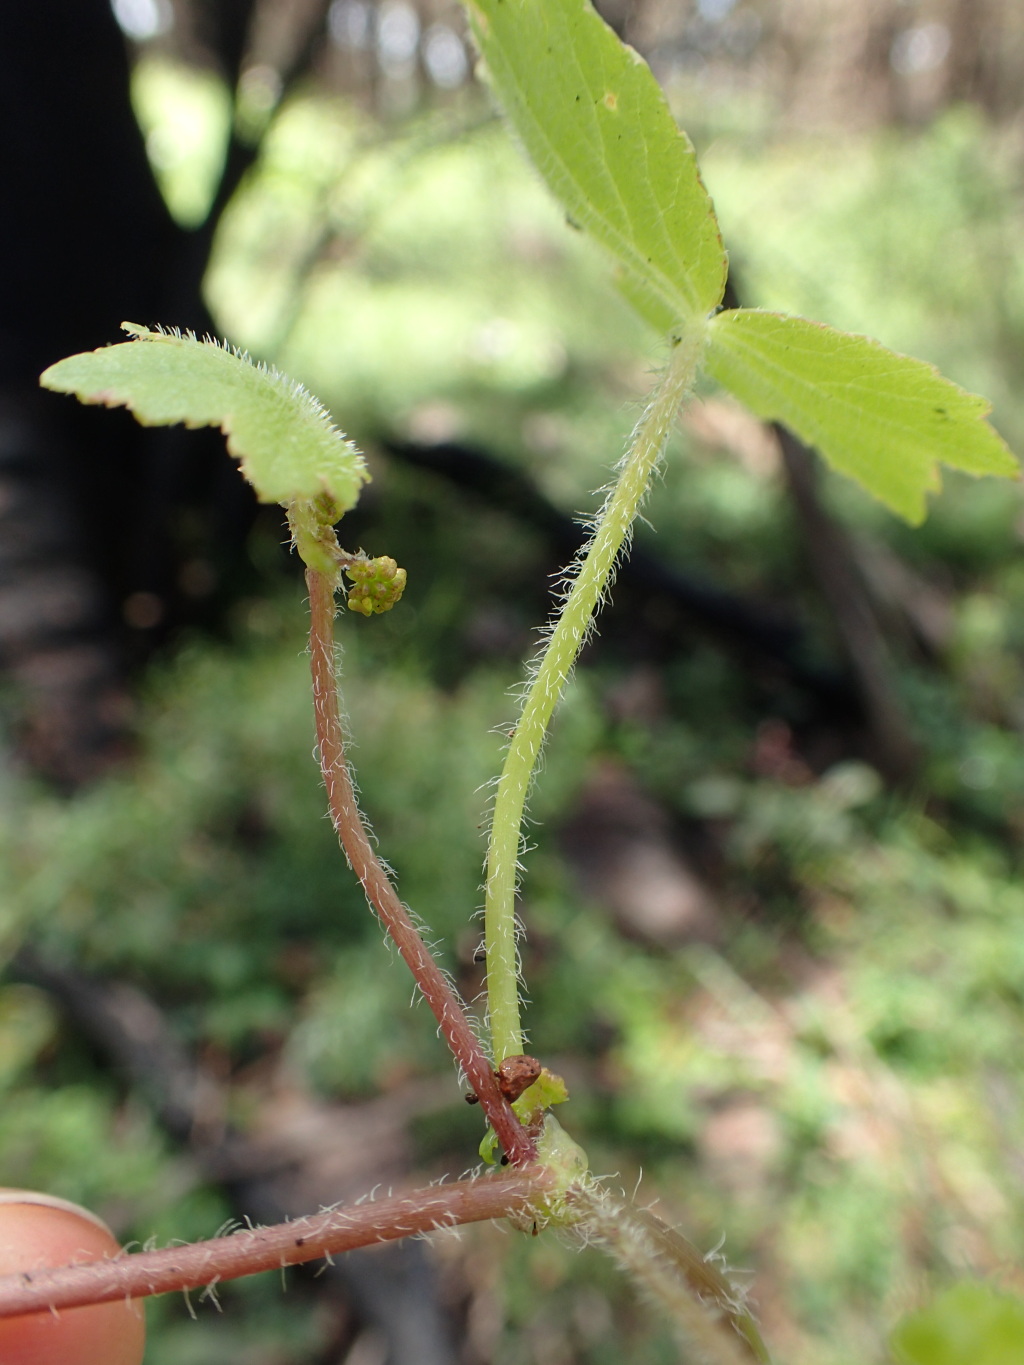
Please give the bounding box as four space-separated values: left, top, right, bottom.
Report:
466 0 726 329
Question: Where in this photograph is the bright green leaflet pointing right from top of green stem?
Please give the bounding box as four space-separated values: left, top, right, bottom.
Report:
706 308 1020 526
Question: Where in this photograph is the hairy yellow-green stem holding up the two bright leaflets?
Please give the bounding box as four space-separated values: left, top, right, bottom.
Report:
485 326 705 1062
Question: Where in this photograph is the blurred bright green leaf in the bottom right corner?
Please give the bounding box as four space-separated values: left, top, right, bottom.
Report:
890 1280 1024 1365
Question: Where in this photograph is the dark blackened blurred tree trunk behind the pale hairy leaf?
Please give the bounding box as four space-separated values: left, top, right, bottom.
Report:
0 0 255 786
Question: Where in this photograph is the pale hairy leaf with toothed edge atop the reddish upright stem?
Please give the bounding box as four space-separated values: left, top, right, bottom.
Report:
40 322 369 521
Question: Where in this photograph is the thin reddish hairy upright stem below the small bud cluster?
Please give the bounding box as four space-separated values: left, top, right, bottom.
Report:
306 569 537 1166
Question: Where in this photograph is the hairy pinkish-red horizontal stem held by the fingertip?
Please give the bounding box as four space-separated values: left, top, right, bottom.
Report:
0 1170 550 1317
